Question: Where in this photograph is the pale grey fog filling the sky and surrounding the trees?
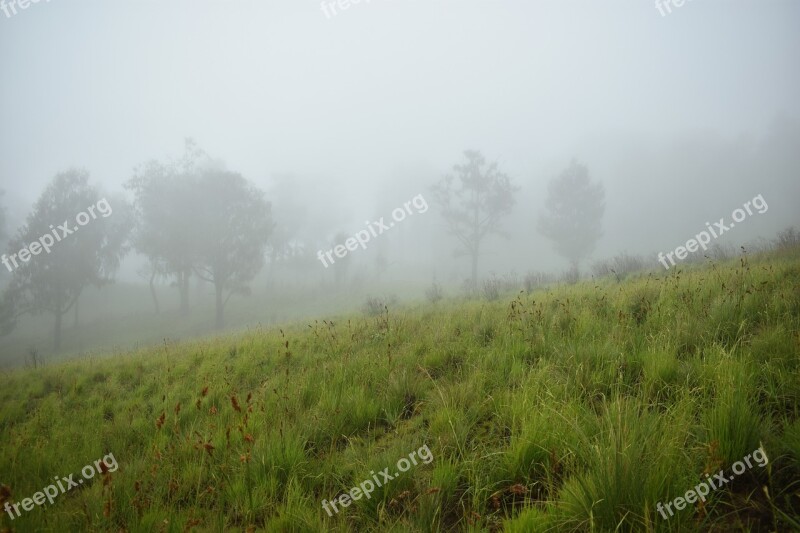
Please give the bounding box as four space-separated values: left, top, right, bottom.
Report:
0 0 800 362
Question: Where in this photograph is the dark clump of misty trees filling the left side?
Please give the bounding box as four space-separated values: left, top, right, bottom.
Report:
0 140 273 351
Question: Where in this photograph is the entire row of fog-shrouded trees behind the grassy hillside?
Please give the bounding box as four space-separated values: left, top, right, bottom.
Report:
0 139 604 351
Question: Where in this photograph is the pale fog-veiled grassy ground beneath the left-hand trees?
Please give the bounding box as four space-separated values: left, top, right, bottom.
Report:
0 276 421 368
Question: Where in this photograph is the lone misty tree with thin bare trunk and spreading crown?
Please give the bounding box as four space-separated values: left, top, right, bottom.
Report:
432 150 519 289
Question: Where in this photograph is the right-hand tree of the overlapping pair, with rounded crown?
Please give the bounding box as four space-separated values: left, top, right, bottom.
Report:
193 169 274 329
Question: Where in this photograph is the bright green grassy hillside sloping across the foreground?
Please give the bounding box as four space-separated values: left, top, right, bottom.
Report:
0 247 800 532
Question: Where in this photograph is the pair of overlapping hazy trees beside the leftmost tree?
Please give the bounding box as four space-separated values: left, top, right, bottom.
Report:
126 139 273 328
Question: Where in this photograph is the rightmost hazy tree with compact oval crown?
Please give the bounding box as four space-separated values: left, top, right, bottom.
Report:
539 159 605 274
